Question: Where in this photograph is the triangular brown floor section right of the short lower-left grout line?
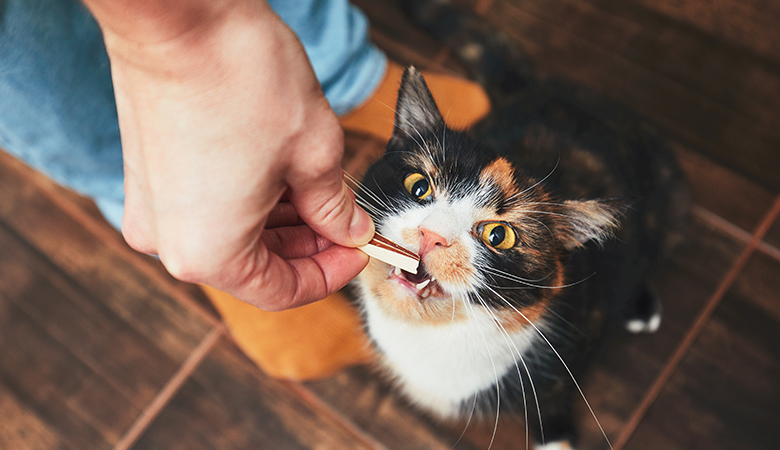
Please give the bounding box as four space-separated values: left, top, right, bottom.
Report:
135 341 370 450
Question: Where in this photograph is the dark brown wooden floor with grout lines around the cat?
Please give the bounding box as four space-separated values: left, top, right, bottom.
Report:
0 0 780 450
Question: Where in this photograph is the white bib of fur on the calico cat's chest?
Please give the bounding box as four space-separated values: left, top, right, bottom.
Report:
364 290 536 417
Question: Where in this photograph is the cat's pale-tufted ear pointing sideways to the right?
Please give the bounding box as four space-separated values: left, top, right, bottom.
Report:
556 198 630 250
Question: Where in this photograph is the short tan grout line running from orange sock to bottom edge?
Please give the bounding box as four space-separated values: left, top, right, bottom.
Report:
113 324 225 450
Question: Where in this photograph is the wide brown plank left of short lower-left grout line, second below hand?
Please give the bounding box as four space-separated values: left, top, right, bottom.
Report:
0 222 187 449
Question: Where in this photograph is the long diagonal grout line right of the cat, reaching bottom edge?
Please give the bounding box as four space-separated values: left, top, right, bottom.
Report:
613 196 780 450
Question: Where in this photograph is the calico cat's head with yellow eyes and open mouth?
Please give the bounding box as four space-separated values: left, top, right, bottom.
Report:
360 68 624 328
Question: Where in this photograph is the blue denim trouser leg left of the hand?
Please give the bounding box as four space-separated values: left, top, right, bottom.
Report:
0 0 124 228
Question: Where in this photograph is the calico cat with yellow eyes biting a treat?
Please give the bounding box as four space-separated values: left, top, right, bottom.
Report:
350 2 687 449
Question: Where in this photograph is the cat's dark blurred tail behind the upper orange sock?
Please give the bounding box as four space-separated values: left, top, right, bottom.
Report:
401 0 536 104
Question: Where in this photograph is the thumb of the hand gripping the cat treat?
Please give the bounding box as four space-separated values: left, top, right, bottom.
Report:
290 167 374 247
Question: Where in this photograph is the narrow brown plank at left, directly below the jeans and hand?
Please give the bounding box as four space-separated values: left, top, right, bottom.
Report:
0 153 208 361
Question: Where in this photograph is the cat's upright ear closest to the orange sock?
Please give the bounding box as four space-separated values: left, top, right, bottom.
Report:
393 66 444 139
